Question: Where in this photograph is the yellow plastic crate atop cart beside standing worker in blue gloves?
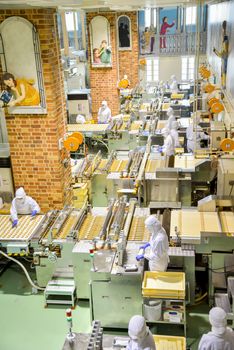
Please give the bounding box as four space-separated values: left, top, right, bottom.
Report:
142 271 185 300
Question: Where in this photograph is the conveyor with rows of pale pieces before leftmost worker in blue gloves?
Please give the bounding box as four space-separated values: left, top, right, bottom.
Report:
0 215 44 241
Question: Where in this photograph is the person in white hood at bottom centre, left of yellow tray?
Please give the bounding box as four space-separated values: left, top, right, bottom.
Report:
126 315 156 350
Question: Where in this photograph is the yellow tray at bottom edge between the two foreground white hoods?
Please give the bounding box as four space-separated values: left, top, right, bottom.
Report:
153 335 186 350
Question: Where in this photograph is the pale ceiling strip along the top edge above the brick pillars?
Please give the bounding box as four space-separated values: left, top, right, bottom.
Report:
0 0 195 11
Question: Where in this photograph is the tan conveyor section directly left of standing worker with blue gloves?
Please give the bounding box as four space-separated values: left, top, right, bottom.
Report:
128 216 150 242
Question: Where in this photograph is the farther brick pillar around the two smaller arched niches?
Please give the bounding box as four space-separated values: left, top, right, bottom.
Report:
87 12 139 119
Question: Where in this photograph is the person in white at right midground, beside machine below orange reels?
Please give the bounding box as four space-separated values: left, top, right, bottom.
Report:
186 118 210 153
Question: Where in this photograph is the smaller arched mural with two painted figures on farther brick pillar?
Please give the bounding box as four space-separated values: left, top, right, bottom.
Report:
90 16 112 68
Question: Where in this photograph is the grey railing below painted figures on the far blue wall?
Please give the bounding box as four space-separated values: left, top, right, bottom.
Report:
154 32 207 56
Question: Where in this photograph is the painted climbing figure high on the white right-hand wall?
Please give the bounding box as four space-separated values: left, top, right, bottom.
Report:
213 21 229 88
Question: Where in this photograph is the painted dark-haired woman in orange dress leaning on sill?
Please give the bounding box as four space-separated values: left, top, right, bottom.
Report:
2 73 40 107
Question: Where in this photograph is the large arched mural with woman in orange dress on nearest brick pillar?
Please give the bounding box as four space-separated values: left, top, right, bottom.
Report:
0 16 46 114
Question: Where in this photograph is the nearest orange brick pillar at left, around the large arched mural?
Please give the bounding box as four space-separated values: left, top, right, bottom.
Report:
0 9 71 211
